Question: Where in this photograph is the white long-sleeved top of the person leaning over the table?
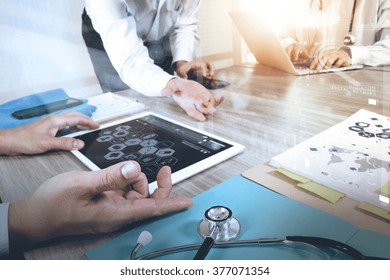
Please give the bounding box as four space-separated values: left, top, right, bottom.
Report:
85 0 200 96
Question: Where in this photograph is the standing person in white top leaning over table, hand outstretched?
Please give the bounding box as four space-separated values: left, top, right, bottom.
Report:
82 0 223 121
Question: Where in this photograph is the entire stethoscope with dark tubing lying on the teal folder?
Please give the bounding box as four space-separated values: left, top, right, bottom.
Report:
130 206 385 260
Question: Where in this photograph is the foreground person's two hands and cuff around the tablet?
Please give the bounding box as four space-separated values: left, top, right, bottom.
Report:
0 113 192 258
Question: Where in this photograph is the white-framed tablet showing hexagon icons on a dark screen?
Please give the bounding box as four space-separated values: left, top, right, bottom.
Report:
66 112 245 192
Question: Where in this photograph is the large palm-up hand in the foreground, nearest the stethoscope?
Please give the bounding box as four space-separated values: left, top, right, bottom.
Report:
9 161 192 249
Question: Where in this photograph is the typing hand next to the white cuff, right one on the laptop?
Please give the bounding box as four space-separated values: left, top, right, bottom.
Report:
310 49 352 70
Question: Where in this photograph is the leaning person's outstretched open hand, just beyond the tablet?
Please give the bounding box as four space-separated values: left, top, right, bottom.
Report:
162 78 223 121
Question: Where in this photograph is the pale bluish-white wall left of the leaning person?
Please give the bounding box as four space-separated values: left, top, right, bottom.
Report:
0 0 100 103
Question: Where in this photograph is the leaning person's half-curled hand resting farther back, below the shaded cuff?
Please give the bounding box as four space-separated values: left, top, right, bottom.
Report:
176 60 215 79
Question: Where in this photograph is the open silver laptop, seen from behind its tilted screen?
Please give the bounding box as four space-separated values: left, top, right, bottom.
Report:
230 12 363 75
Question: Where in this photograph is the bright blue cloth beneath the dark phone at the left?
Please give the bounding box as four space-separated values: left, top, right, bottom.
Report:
0 89 96 129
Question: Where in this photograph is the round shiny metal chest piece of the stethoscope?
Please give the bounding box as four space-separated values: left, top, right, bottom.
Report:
198 206 241 242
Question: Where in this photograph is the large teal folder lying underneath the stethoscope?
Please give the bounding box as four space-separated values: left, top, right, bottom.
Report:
87 176 390 260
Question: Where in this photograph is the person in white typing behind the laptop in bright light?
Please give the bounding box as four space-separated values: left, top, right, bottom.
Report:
281 0 390 70
